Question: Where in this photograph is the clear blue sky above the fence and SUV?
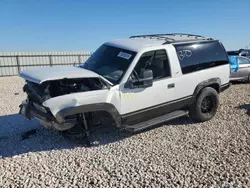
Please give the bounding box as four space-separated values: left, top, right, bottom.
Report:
0 0 250 52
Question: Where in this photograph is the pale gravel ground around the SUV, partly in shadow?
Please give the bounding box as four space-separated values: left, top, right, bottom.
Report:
0 77 250 187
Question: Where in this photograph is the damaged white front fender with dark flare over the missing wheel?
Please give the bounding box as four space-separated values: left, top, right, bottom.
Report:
43 89 121 124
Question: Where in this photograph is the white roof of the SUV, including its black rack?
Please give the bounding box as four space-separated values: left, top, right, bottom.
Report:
105 33 213 52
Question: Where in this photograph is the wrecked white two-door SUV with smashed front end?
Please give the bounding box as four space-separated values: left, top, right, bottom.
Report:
20 33 230 144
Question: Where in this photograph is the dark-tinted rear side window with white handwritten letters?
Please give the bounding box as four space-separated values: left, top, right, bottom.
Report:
174 42 229 74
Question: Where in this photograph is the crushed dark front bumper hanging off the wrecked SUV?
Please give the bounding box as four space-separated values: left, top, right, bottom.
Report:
19 100 76 131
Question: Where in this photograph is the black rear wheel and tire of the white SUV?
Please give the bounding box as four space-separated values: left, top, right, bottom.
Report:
189 87 219 122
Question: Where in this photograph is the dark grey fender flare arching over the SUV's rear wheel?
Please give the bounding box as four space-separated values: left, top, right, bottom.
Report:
193 78 221 97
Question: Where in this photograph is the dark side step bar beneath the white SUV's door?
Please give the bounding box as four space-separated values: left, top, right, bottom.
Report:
124 110 188 133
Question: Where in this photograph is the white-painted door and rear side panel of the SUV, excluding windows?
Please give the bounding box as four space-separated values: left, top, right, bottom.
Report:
119 44 230 114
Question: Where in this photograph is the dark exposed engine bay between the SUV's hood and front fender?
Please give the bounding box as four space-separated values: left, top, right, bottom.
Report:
23 78 108 104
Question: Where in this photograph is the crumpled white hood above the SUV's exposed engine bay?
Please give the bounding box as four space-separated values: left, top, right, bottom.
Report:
19 66 112 85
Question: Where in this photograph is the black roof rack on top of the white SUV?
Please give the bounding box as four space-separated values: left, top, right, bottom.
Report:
129 33 213 44
